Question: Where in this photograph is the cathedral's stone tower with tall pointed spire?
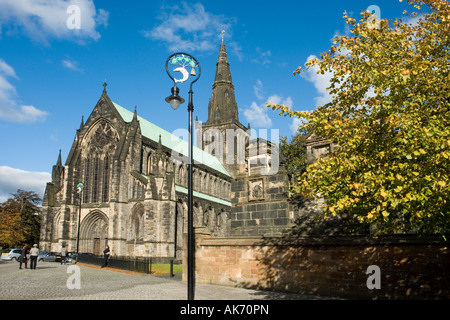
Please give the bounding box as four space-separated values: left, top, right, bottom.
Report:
197 39 248 177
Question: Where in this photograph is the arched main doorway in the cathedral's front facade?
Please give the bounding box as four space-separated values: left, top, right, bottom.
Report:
79 210 109 255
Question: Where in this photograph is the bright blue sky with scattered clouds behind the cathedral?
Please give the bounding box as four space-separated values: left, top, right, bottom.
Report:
0 0 410 202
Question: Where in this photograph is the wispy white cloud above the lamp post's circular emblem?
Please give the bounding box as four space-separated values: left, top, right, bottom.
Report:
143 2 242 59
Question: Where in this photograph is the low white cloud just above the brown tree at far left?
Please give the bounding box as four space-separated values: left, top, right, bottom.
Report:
0 166 51 203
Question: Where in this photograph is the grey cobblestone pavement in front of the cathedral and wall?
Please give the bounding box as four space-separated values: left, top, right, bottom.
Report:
0 261 328 300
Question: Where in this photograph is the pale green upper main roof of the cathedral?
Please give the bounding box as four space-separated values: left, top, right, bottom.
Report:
113 102 230 176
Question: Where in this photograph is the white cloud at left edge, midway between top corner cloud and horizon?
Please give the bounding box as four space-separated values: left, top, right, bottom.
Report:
0 58 48 122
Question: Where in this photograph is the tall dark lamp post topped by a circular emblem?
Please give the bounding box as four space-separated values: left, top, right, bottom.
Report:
166 53 201 300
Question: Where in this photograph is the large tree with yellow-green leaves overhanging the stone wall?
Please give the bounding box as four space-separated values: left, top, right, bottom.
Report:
268 0 450 234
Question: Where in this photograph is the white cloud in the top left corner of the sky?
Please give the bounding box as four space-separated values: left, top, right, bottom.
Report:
0 0 109 42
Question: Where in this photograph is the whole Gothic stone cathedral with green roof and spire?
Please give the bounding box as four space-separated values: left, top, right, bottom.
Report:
40 41 329 258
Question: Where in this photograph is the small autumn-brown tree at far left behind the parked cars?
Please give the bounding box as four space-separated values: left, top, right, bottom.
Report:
0 189 42 246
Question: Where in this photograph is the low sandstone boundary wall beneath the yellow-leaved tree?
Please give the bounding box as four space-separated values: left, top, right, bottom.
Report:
183 228 450 299
